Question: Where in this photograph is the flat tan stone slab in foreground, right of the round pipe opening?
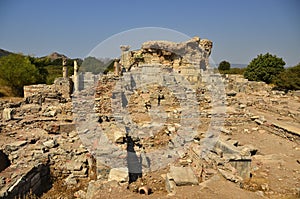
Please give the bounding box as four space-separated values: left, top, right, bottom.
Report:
170 166 198 186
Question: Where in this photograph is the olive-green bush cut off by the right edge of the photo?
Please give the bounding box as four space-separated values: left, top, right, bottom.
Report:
275 63 300 91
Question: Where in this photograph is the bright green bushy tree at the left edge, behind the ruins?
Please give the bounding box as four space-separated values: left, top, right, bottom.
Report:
0 54 39 96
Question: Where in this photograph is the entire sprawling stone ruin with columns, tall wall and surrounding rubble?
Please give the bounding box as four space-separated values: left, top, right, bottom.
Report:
0 37 300 198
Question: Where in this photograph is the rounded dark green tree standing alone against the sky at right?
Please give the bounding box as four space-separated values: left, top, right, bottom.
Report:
244 53 285 84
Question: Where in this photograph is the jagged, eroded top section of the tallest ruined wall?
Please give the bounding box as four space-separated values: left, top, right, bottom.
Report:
120 37 212 84
